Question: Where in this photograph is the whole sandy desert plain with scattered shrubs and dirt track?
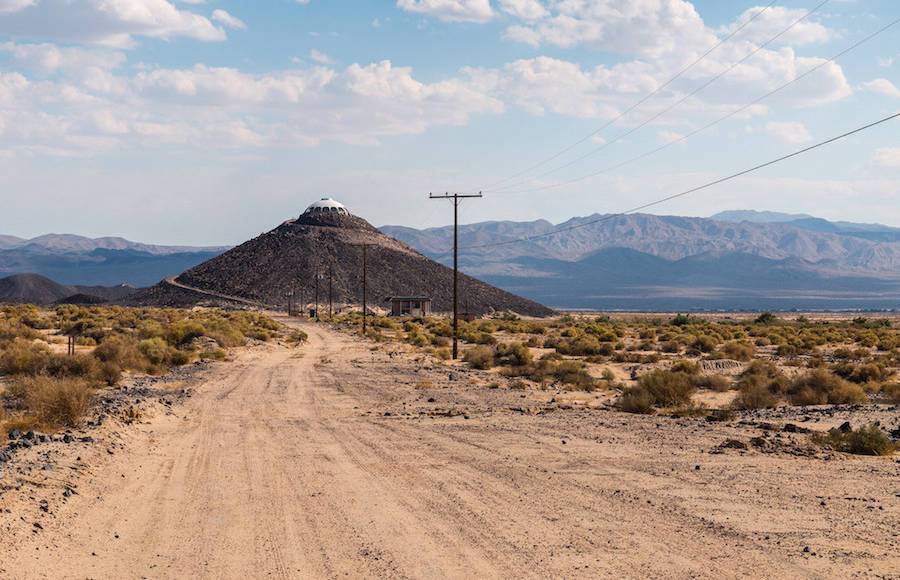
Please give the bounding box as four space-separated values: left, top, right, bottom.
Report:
0 306 900 578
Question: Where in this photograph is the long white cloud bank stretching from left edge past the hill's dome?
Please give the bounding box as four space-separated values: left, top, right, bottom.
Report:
0 61 503 156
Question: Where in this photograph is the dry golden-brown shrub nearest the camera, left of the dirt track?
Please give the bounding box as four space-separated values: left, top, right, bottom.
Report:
6 376 92 428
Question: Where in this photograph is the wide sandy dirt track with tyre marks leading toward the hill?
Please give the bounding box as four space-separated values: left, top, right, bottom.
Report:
0 324 900 578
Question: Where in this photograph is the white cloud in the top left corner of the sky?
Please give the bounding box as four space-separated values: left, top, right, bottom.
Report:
0 0 225 47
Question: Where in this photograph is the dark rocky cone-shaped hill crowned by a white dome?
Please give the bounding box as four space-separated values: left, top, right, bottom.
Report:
128 200 553 316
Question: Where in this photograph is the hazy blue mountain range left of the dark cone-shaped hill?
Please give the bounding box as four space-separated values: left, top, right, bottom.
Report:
0 234 228 286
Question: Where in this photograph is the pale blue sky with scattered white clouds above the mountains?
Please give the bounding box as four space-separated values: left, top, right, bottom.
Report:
0 0 900 245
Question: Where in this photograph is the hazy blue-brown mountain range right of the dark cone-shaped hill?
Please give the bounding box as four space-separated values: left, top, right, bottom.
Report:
381 211 900 310
